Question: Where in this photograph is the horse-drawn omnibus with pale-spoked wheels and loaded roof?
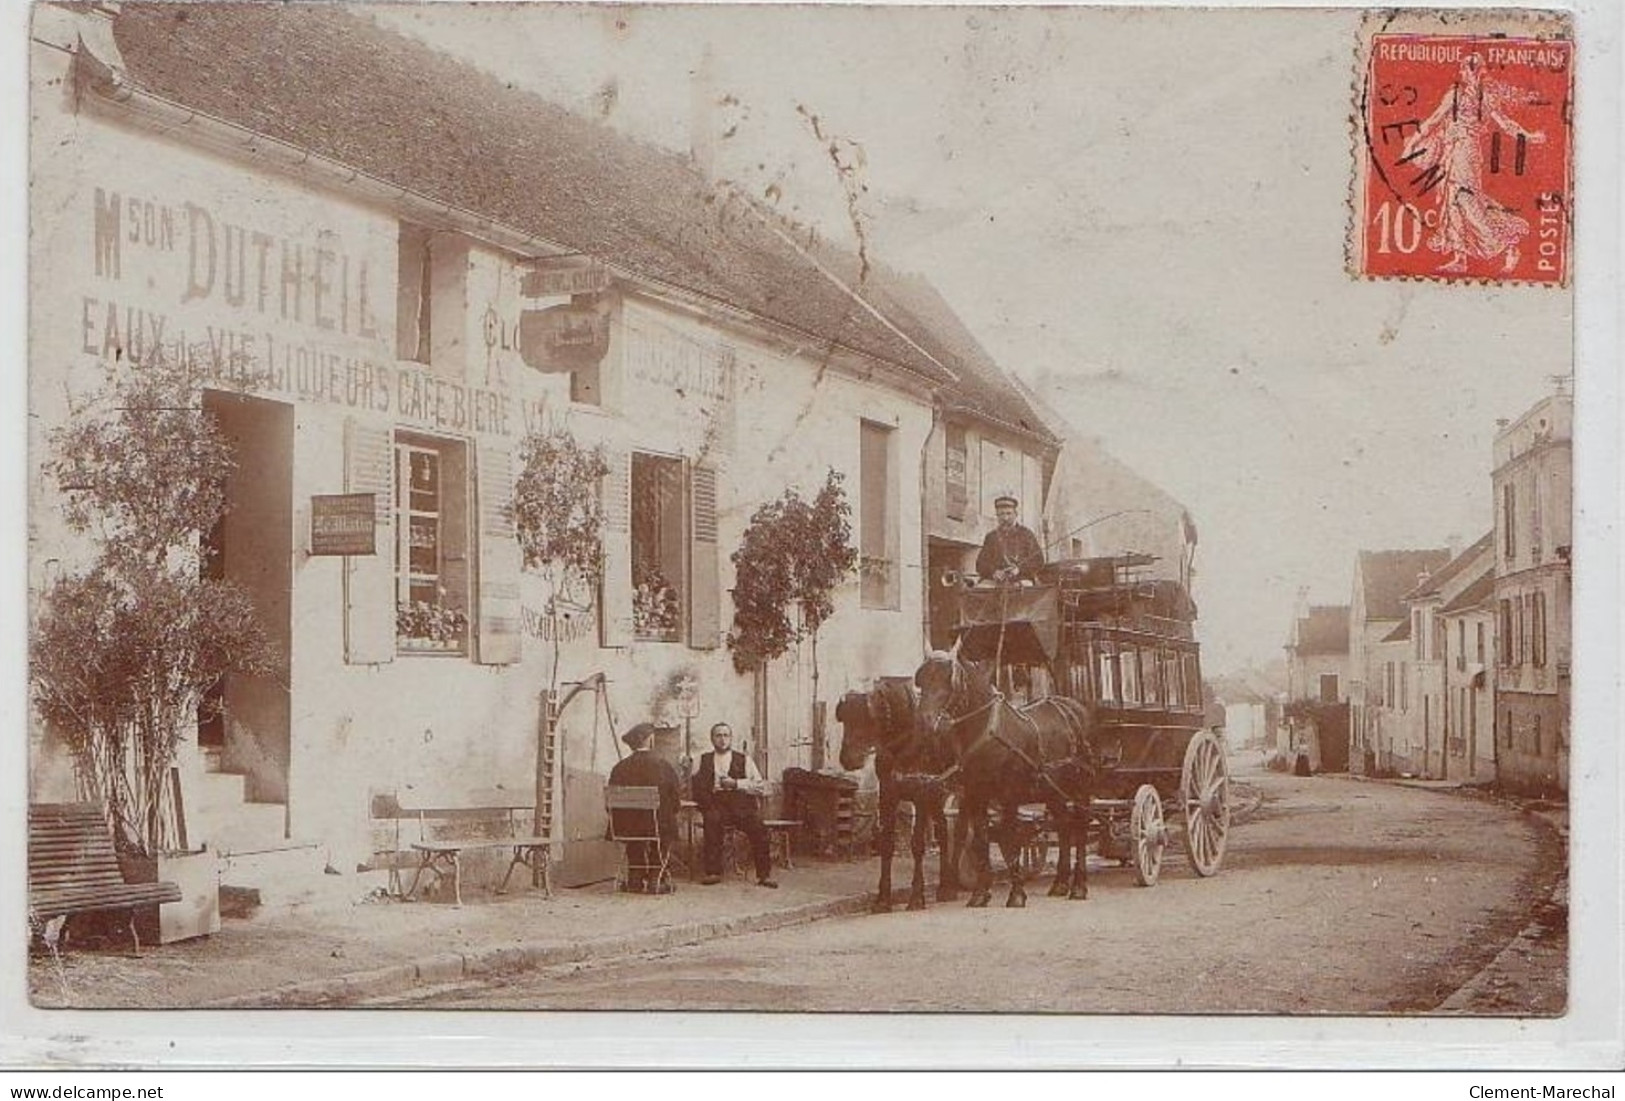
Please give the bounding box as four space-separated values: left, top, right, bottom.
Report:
956 554 1230 887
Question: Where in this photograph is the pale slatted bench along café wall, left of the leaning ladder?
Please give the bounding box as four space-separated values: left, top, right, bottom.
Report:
372 794 554 906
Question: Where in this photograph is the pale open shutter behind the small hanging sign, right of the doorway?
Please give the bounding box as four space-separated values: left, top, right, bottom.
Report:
345 417 395 666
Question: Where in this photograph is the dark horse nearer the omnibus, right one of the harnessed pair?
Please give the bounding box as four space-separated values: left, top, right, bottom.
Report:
915 653 1097 906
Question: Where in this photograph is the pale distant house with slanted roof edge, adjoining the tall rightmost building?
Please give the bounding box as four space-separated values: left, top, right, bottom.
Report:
1402 533 1493 779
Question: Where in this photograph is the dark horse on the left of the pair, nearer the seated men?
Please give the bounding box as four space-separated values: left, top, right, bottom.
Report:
835 680 959 914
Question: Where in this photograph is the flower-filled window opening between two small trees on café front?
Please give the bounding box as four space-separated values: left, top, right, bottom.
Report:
632 453 686 641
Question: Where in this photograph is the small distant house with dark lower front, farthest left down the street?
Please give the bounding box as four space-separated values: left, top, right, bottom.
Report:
1277 598 1349 771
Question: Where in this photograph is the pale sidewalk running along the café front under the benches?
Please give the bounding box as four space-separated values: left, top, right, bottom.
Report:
28 859 895 1008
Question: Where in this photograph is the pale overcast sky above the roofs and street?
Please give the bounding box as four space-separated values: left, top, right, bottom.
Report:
380 5 1573 672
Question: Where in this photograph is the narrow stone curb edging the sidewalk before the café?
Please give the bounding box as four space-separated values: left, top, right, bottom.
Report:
198 892 874 1008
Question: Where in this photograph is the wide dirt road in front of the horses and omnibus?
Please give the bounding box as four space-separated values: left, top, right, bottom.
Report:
397 768 1567 1013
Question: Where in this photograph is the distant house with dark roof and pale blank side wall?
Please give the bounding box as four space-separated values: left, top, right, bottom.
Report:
1349 547 1451 771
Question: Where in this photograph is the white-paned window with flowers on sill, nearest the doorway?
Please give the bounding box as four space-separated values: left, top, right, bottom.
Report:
393 432 470 654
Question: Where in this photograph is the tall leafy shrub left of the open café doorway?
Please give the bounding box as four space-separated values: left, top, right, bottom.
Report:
29 357 275 854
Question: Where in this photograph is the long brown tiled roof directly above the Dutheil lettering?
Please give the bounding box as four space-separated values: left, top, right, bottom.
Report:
114 3 975 390
